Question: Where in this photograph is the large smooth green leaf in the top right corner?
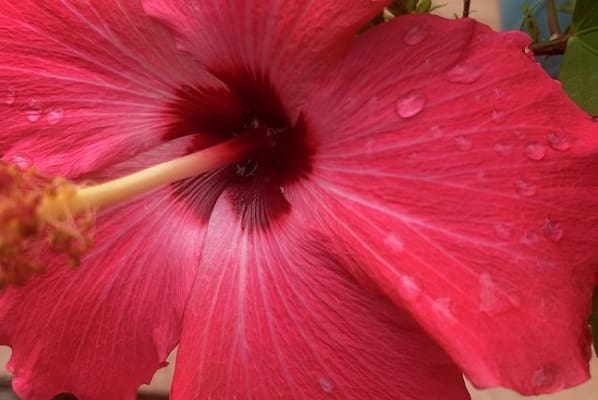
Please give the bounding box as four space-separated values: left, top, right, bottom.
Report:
559 0 598 115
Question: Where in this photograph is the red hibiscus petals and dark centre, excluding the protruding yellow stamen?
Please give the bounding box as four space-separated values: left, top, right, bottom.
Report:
0 0 598 400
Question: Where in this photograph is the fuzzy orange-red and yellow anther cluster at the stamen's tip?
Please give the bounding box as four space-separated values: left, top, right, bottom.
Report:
0 163 93 289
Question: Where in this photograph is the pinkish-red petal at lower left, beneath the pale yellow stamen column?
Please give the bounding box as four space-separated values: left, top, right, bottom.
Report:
0 140 210 400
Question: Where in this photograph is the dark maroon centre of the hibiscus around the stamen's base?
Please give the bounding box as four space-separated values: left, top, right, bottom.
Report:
164 72 310 229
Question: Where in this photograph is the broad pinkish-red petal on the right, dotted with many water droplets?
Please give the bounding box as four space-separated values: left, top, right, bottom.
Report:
305 16 598 394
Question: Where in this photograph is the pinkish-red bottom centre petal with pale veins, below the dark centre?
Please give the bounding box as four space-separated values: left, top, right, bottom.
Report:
171 201 469 400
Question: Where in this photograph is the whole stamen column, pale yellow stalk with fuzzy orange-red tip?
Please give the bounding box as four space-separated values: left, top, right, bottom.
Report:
0 130 262 289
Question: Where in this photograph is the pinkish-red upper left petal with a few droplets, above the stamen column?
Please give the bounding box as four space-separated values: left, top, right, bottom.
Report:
0 0 235 176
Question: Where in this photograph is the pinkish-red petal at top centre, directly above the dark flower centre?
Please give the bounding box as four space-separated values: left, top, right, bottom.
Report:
142 0 389 117
